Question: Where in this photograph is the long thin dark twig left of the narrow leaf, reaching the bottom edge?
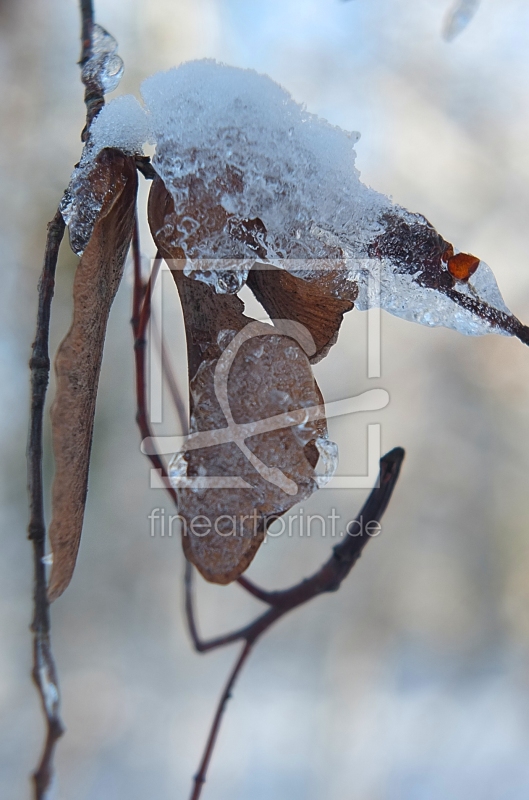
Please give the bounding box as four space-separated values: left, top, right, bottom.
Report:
27 211 65 800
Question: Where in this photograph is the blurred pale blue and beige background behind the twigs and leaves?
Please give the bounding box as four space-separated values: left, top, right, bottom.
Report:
0 0 529 800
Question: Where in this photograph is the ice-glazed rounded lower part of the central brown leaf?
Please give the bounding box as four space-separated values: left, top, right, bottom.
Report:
175 323 328 583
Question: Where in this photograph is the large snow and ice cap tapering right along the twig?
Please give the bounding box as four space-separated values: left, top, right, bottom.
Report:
142 61 512 335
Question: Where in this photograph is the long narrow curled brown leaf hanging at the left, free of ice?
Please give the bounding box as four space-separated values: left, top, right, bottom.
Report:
48 149 137 601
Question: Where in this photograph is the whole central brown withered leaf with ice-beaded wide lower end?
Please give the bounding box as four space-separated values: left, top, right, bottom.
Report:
149 180 327 584
